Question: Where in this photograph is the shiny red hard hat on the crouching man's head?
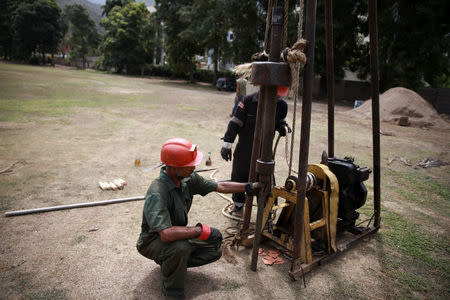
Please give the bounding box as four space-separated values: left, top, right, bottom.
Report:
161 138 203 167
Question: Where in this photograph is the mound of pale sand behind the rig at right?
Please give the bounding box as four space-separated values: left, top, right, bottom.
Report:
350 87 449 127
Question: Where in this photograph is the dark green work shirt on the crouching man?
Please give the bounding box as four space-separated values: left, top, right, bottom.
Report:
138 168 217 247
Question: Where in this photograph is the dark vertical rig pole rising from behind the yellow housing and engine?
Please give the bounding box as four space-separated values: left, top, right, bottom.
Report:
325 0 335 157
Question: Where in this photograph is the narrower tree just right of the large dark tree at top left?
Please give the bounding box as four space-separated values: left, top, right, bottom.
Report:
65 4 100 69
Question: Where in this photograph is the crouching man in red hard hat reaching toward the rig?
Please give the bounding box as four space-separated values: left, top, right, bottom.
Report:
136 138 257 298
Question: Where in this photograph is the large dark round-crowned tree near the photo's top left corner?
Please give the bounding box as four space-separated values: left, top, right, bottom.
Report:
13 0 64 62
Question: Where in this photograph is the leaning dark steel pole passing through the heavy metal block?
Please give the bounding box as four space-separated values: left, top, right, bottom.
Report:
250 7 283 271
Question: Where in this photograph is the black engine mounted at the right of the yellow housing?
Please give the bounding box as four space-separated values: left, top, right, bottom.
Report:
328 157 371 231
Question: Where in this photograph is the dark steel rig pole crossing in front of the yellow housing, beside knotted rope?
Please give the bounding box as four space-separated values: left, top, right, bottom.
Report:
292 0 317 260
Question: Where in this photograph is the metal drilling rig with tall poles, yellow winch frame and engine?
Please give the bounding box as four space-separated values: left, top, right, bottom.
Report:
237 0 380 279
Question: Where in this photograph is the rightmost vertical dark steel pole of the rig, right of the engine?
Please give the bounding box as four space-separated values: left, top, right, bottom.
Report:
369 0 381 228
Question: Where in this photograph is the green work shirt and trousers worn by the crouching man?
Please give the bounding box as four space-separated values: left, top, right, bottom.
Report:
136 168 222 296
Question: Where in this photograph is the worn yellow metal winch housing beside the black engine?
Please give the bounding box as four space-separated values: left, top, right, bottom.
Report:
262 164 339 264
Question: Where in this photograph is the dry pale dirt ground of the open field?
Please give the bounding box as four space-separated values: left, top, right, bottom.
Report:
0 62 450 299
